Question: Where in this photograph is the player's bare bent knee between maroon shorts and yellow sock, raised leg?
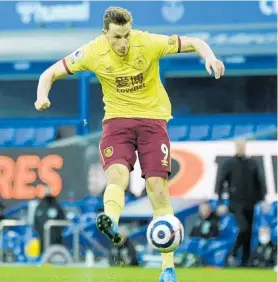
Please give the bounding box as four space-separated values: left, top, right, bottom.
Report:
105 164 129 189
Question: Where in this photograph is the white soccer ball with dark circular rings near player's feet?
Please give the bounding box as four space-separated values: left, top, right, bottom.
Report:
147 215 184 253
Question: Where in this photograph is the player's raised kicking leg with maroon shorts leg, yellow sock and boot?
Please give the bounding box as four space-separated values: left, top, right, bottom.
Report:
97 119 136 245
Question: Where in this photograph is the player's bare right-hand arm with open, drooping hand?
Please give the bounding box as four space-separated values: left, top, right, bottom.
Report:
180 36 225 79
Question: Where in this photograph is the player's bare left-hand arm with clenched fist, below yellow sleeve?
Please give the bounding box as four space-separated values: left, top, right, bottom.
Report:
35 61 68 111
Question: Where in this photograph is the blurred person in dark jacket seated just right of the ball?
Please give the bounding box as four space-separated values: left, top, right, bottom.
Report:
189 203 219 239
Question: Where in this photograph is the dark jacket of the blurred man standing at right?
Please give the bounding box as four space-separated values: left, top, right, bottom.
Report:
216 156 266 208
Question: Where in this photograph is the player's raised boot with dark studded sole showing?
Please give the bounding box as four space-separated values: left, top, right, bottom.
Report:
96 213 123 246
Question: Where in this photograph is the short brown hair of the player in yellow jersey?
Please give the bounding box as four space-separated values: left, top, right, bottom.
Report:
103 7 132 30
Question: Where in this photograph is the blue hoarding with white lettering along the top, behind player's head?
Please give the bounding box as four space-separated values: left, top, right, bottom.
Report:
0 0 278 31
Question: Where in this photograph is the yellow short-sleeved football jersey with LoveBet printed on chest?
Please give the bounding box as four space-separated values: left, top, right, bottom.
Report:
63 30 180 120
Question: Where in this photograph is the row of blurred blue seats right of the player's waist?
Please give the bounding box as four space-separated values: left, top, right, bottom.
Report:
168 115 277 141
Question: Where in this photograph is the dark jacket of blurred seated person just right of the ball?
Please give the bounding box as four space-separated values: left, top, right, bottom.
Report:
190 212 219 239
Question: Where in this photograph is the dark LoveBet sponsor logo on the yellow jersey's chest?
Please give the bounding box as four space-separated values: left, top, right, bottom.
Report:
115 73 146 93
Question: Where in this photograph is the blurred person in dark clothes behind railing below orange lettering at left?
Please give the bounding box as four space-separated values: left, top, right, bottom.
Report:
34 186 66 252
